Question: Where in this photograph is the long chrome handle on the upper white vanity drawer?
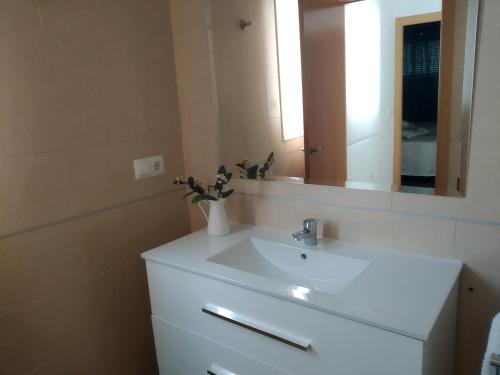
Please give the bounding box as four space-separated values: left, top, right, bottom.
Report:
201 303 311 352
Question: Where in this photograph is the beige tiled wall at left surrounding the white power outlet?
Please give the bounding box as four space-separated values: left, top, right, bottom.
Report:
0 0 189 375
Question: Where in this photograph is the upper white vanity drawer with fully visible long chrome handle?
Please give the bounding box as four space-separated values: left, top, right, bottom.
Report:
147 262 423 375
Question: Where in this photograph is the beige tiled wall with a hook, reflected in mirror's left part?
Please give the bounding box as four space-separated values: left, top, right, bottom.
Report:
210 0 304 181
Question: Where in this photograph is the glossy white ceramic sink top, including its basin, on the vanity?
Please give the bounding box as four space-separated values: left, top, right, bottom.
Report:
143 225 462 341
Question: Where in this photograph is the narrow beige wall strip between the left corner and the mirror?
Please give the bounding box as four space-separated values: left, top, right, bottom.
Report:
170 0 220 230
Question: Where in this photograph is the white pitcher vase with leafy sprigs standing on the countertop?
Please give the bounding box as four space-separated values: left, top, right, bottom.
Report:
174 165 234 236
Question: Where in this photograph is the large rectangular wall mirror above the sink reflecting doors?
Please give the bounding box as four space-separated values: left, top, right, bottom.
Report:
209 0 478 196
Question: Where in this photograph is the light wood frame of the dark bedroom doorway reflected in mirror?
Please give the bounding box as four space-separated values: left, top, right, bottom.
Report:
392 12 442 191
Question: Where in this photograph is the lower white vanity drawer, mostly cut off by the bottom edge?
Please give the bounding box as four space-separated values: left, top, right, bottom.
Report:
153 318 287 375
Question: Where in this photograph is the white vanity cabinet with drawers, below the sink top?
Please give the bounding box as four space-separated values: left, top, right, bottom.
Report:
144 226 457 375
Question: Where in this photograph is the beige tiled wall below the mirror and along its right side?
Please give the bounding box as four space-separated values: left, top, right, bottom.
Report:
225 0 500 375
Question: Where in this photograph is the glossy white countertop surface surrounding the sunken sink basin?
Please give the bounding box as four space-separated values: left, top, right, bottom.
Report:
142 224 462 341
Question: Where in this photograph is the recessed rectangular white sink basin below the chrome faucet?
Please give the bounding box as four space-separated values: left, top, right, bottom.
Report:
207 238 369 299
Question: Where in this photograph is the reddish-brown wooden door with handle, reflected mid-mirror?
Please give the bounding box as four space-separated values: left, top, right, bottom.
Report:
298 0 346 187
